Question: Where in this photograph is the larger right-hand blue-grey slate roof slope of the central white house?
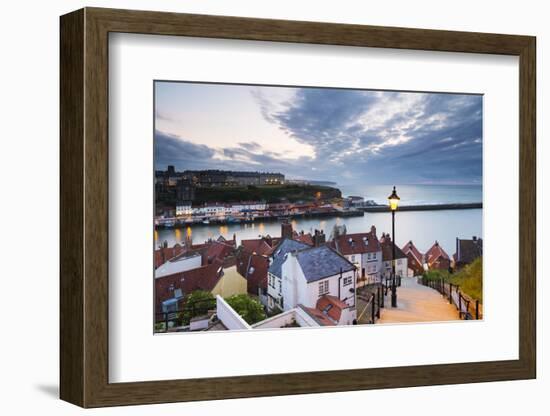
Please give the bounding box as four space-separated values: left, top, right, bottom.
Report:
296 246 355 283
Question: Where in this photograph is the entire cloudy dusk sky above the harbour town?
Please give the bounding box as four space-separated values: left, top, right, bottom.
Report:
154 81 483 185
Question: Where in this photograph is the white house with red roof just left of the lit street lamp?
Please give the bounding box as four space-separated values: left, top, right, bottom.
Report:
331 226 382 285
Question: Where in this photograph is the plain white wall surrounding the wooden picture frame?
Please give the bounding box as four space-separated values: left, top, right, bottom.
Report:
0 0 550 416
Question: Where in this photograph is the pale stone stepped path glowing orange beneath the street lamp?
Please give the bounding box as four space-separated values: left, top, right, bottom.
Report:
376 277 459 324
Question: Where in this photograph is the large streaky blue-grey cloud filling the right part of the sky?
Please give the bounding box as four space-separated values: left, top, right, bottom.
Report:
262 88 482 183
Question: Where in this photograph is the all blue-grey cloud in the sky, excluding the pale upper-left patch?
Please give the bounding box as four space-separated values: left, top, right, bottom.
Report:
155 87 483 184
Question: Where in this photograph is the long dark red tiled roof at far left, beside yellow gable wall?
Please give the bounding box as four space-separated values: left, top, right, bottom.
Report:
155 262 223 312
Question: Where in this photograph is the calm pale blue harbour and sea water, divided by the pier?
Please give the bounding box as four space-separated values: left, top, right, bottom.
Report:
155 185 483 255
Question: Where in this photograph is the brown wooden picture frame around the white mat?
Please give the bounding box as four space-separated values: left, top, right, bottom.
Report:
60 8 536 407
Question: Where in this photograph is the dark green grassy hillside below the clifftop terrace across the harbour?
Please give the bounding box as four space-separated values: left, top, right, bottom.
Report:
193 185 342 204
